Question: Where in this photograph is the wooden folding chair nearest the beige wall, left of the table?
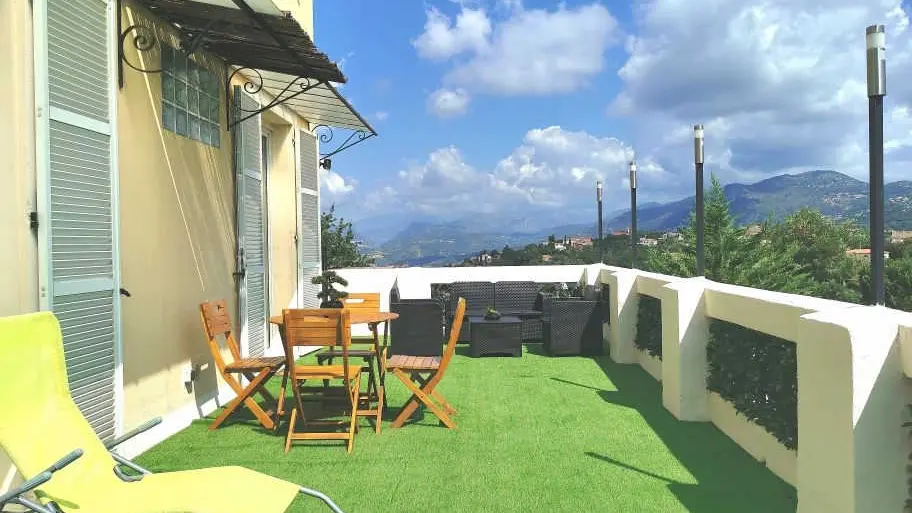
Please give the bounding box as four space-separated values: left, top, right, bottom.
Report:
200 299 285 429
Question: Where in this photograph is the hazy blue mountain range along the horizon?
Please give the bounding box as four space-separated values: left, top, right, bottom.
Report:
355 170 912 265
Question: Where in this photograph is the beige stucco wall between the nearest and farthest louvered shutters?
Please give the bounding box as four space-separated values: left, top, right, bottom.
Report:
118 4 306 429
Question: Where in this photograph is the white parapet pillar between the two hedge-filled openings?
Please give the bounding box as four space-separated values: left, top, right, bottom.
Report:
662 278 710 421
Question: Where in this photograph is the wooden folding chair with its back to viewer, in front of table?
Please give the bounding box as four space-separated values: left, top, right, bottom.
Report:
282 308 361 453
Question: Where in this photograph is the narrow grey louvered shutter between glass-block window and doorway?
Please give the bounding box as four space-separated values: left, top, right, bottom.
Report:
235 87 268 356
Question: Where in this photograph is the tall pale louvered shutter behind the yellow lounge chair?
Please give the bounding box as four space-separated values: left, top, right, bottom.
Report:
33 0 122 439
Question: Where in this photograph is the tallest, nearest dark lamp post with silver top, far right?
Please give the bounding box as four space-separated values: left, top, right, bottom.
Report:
865 25 887 305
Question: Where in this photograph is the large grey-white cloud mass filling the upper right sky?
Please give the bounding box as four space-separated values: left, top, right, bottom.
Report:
608 0 912 184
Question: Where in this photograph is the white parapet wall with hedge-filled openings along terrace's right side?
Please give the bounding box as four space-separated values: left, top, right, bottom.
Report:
590 267 912 513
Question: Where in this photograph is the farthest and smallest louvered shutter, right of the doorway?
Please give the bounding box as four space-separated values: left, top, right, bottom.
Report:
298 130 322 308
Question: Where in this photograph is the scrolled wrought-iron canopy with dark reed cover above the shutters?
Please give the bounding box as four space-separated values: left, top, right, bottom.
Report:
117 0 377 158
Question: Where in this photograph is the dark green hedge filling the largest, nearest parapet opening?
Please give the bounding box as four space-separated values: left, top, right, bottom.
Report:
706 319 798 449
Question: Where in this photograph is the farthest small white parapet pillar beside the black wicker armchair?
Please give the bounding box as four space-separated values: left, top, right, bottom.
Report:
600 270 639 363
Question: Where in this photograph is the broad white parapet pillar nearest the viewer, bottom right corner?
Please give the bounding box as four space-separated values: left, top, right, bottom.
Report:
797 307 910 513
